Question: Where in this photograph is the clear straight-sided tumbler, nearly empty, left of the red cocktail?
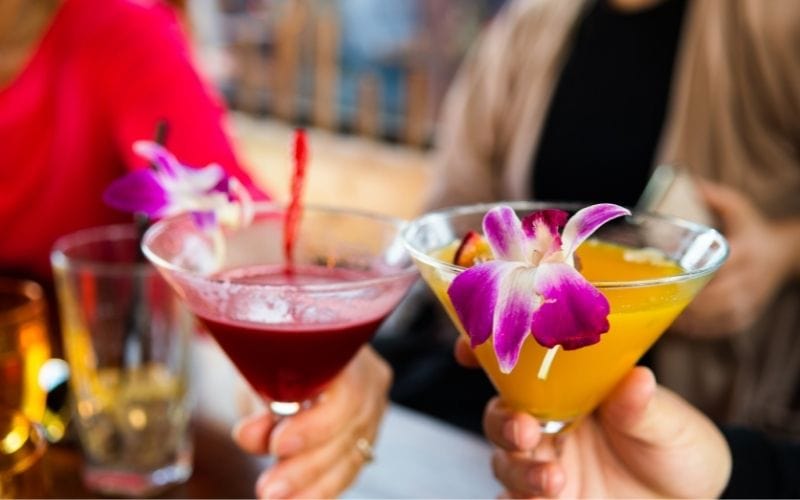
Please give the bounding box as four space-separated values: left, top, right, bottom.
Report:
51 225 193 496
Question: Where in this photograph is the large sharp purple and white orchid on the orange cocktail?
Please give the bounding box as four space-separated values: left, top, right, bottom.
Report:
447 203 630 376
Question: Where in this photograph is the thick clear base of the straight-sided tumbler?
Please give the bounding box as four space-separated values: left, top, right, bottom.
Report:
83 451 192 497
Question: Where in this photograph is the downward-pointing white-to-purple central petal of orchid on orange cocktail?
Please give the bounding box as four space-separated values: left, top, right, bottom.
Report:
493 265 540 373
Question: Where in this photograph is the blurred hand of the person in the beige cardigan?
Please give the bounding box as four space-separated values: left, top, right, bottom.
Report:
673 182 797 338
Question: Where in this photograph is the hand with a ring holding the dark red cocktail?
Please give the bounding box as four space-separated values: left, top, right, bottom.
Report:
233 346 392 498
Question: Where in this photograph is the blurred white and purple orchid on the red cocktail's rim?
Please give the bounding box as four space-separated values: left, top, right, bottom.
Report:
103 141 252 228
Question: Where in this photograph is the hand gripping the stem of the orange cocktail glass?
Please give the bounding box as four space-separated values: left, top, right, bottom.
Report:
484 367 731 498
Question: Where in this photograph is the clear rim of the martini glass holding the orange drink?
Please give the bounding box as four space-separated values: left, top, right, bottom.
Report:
403 201 730 290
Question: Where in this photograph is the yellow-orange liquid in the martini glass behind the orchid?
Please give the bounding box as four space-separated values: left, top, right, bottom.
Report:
420 240 708 424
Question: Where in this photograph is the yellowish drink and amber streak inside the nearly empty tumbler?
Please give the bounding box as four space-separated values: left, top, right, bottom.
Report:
56 278 191 471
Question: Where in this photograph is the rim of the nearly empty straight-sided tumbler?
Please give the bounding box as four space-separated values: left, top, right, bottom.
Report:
50 222 154 276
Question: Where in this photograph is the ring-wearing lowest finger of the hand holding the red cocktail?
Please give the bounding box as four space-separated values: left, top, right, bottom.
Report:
256 420 375 498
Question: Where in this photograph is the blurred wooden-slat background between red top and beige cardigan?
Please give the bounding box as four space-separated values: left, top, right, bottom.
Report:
179 0 503 217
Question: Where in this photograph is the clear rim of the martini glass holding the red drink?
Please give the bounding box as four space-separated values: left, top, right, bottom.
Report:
142 201 418 293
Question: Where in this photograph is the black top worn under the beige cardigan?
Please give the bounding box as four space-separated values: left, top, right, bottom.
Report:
532 0 686 206
